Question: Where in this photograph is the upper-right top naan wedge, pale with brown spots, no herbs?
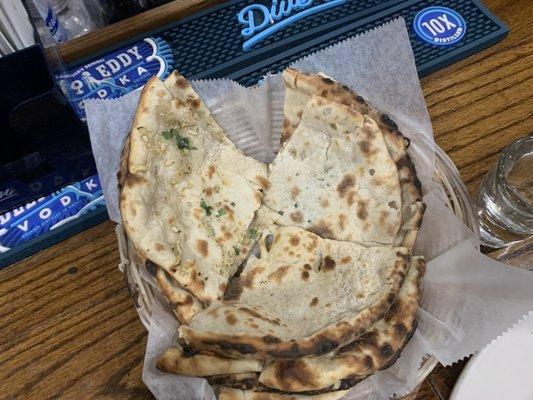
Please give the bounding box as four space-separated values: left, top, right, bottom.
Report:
264 96 402 245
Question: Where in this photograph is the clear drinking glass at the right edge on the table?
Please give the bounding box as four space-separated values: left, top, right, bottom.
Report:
475 134 533 248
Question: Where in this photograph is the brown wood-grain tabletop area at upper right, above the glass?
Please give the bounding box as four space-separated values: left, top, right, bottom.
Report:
422 0 533 192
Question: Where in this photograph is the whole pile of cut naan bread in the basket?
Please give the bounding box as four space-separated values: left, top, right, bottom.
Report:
129 69 424 400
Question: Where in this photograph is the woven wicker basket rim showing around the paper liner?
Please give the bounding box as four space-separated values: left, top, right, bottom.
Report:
115 146 479 386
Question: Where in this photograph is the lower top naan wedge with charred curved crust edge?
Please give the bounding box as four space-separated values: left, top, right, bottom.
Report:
178 227 409 359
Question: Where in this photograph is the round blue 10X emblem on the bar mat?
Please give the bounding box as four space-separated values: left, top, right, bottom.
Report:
413 7 466 46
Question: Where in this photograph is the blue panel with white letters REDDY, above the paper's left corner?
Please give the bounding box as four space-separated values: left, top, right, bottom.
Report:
56 37 174 120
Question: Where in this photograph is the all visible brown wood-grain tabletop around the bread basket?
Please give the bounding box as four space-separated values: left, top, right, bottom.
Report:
0 0 533 400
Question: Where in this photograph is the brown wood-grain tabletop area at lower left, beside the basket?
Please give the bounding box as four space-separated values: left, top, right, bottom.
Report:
0 222 151 400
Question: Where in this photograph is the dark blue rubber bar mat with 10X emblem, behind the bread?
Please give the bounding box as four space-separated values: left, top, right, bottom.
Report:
73 0 509 86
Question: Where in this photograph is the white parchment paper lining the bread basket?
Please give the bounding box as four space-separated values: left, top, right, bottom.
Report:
86 18 533 400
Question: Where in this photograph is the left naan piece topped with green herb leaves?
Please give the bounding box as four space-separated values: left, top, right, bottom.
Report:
120 74 268 304
